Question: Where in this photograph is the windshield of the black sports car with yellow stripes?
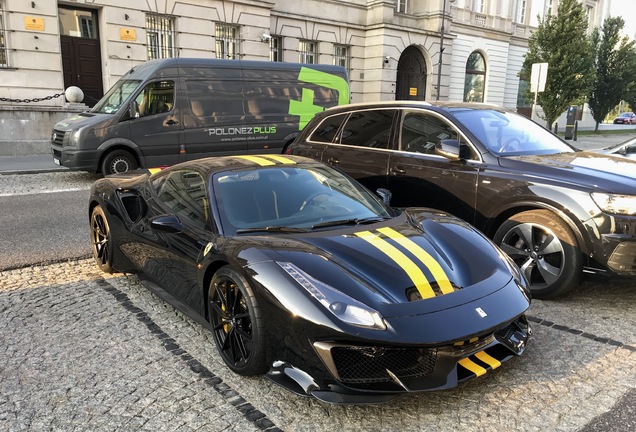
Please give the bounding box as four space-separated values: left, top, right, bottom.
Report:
212 165 391 233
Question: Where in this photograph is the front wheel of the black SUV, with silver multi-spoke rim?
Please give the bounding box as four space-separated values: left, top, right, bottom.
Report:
494 210 583 299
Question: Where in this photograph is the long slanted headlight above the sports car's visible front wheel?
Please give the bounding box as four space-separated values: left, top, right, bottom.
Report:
278 262 386 330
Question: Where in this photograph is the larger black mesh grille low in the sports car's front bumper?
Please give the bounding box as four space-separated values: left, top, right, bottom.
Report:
331 346 437 384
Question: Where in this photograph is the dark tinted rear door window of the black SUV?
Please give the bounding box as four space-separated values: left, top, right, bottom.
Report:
340 110 396 149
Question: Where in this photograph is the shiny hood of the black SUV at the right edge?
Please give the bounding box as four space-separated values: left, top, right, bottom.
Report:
499 151 636 195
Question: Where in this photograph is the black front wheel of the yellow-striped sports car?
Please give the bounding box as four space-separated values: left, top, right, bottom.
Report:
208 266 267 375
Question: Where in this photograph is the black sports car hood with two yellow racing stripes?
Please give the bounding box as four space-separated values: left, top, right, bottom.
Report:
238 210 511 315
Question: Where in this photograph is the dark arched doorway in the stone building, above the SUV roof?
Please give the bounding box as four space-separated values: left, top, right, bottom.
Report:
395 46 426 101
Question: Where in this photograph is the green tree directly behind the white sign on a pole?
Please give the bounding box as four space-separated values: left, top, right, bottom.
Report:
520 0 595 128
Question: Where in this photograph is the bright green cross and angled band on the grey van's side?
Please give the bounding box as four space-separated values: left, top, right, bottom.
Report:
289 67 349 130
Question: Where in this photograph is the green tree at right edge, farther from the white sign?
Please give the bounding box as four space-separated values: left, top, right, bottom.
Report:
588 17 636 131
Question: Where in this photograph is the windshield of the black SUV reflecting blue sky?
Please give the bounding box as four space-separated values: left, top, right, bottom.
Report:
452 109 574 156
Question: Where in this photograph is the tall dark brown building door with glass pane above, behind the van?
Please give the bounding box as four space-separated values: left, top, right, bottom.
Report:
59 7 104 107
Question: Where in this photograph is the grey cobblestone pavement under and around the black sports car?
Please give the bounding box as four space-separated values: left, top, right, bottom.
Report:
0 260 636 431
